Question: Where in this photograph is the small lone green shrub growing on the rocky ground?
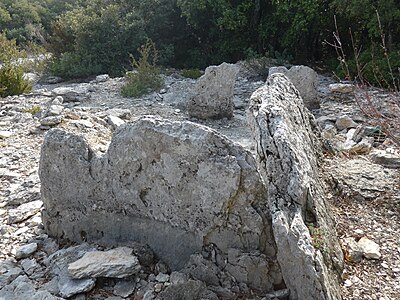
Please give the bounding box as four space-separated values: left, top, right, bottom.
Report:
121 41 163 97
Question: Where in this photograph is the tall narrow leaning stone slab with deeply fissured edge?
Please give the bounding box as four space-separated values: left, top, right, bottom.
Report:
250 74 343 300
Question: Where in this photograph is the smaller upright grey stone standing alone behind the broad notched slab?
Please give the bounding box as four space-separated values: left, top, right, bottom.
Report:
187 63 239 119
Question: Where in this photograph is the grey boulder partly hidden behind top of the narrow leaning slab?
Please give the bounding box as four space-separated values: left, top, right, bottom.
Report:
269 66 320 109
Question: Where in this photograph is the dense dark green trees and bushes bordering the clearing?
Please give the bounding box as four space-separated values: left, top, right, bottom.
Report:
0 0 400 86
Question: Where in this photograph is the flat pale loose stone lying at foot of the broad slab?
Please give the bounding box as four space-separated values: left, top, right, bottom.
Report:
68 247 140 278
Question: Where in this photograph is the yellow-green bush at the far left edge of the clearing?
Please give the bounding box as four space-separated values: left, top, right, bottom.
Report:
0 33 31 97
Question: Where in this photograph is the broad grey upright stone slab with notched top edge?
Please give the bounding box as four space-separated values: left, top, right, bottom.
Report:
39 117 284 292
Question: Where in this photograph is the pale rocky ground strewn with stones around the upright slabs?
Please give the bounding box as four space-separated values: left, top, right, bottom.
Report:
0 64 400 300
